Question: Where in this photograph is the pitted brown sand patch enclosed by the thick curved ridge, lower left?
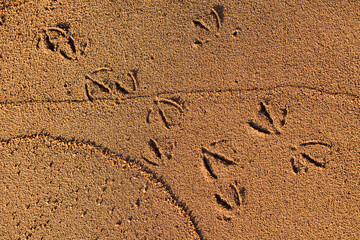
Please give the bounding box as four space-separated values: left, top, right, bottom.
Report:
0 133 204 239
